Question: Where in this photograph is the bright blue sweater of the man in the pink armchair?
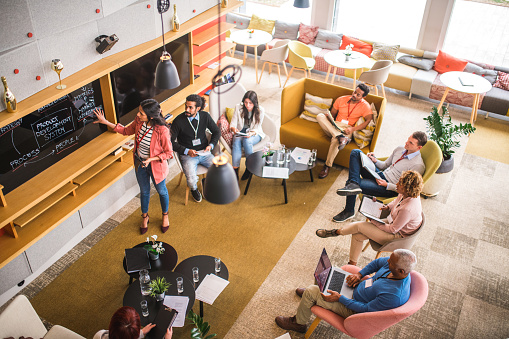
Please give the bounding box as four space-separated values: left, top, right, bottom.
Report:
339 258 411 313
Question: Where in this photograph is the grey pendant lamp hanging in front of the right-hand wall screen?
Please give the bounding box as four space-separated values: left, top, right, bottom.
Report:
155 0 180 89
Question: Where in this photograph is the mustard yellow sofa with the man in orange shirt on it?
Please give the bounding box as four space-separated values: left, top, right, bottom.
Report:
279 78 386 167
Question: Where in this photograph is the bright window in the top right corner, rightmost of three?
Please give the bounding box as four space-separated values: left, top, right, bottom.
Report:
442 0 509 67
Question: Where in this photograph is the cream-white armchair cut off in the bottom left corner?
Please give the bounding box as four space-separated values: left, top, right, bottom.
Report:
0 294 85 339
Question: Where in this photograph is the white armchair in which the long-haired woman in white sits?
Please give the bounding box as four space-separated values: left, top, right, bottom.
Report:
209 82 277 154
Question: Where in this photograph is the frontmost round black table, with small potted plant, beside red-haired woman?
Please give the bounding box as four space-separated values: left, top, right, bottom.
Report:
122 271 195 326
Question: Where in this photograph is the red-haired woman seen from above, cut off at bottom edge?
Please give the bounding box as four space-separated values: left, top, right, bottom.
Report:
93 306 173 339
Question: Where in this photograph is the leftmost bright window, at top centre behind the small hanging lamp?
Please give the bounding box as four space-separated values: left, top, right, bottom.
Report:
240 0 313 25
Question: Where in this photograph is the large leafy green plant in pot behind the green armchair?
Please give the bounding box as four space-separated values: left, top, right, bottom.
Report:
423 106 475 196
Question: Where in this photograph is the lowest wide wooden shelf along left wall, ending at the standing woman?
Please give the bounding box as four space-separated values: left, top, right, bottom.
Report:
0 161 132 268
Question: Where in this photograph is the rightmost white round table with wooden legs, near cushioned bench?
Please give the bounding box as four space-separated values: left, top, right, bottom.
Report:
438 71 492 124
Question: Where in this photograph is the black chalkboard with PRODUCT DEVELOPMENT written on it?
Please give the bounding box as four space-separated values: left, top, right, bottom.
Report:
0 80 106 194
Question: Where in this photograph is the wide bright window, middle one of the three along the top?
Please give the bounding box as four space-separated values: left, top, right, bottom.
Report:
332 0 426 48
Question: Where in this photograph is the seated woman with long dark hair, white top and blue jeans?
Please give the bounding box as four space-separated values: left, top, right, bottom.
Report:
230 91 265 180
